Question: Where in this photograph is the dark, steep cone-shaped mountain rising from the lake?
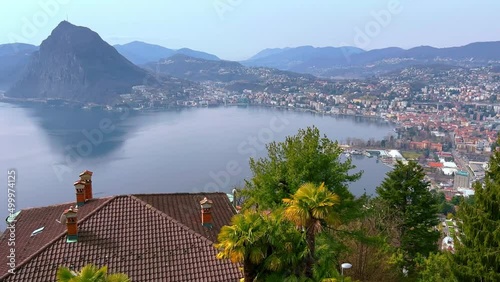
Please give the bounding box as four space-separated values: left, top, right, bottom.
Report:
6 21 155 103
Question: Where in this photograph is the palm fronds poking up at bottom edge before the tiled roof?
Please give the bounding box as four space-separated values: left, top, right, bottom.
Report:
57 264 130 282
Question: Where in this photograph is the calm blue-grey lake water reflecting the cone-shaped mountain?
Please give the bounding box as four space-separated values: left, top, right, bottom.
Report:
0 103 392 229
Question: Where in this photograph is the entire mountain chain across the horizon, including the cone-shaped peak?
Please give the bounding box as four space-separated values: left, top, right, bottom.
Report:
0 21 500 103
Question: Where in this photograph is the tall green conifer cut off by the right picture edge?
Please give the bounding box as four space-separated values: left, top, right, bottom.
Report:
452 147 500 282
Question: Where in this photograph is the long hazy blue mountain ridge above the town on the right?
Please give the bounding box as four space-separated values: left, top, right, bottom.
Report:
241 41 500 76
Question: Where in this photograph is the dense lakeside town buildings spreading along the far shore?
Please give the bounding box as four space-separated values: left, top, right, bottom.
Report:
114 66 500 196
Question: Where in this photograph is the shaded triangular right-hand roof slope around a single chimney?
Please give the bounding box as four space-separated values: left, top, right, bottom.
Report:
134 193 236 242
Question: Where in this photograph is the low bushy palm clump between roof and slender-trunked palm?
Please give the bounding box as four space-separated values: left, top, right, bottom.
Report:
215 209 308 281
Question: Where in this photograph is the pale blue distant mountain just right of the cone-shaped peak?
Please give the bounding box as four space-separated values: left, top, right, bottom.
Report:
114 41 220 65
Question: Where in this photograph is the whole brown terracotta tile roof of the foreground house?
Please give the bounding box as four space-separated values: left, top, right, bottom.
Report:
0 193 242 282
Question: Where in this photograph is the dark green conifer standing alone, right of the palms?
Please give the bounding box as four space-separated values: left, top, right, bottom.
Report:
377 161 439 275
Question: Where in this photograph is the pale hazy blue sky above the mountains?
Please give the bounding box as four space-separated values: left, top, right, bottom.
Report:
0 0 500 60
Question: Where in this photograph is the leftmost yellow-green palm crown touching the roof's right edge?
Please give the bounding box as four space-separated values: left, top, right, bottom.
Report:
215 211 267 282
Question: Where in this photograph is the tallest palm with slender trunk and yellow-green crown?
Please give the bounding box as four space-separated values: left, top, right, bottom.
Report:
283 183 339 278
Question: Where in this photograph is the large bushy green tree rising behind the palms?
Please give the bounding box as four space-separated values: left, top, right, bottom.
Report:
242 127 361 221
